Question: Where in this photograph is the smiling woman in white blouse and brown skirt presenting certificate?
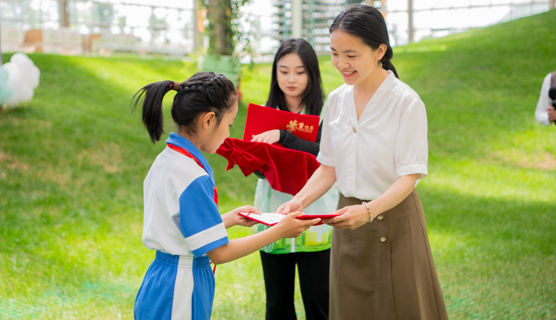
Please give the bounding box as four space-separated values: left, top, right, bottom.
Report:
278 5 448 320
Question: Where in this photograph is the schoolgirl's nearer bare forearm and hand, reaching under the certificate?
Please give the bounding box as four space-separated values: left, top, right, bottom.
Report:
207 212 320 264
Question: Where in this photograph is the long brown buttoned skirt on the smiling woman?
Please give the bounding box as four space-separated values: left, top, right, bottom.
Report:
330 190 448 320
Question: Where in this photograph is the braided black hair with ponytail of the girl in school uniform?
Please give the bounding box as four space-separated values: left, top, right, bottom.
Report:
131 72 237 143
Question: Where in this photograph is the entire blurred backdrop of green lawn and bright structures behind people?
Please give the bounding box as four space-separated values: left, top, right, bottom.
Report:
0 0 556 320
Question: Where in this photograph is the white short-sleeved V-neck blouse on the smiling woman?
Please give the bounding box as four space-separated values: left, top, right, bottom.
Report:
317 71 428 200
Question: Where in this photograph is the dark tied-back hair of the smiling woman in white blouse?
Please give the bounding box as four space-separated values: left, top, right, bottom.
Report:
330 5 399 79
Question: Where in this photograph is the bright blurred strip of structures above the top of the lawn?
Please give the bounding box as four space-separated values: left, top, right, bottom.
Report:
0 0 554 62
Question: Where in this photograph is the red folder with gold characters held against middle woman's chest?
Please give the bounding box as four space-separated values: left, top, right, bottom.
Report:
243 103 320 142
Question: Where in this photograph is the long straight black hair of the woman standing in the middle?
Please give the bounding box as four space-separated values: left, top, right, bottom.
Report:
266 39 323 116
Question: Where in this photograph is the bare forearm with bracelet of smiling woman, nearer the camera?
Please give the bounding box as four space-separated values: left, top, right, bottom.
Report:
323 174 418 230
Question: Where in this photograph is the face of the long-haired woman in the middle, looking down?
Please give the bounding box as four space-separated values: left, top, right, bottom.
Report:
276 53 309 107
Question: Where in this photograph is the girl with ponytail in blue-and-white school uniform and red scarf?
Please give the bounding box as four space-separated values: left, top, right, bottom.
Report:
132 72 320 320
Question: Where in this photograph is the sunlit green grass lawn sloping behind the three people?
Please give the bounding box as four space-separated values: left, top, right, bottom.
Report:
0 10 556 320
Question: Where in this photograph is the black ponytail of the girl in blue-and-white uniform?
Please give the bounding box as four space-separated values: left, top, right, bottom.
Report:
131 81 177 144
